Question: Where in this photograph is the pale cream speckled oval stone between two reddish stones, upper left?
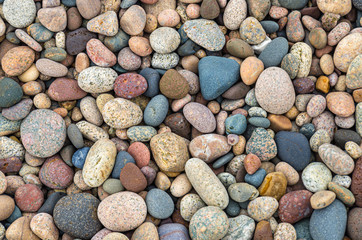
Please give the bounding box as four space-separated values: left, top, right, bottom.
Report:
78 67 118 93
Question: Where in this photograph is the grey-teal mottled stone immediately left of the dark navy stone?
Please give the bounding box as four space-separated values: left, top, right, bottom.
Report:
245 128 278 161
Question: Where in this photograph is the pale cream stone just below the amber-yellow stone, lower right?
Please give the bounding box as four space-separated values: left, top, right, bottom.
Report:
247 197 279 222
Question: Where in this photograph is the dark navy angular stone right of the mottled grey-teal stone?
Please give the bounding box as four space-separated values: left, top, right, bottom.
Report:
275 131 312 171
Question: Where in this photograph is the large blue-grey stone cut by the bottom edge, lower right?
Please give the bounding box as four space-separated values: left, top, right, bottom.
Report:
309 199 347 240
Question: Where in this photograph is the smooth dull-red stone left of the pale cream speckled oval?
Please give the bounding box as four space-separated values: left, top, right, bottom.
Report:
48 78 87 102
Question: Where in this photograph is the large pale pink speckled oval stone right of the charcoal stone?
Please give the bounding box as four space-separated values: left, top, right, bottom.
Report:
97 191 147 232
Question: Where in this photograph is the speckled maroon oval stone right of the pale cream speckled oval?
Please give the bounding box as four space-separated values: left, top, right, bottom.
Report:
114 73 148 99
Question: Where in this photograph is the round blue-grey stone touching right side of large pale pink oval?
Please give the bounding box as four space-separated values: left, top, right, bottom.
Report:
146 188 174 219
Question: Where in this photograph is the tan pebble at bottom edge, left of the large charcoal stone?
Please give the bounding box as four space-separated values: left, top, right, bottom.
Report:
30 213 59 240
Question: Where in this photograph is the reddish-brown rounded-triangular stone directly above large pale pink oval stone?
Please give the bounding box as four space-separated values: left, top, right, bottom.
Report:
119 163 147 193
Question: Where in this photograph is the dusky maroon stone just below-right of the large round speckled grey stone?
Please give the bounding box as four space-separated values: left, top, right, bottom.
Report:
39 155 74 189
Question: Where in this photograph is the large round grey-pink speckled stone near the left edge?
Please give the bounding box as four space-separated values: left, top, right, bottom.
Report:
20 109 66 157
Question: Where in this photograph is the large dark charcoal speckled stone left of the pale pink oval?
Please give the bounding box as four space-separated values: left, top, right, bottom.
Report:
53 193 102 239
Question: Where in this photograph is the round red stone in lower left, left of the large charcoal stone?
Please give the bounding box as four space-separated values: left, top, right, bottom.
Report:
15 184 44 212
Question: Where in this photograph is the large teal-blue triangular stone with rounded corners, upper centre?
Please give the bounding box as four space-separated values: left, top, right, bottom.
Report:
198 56 240 100
